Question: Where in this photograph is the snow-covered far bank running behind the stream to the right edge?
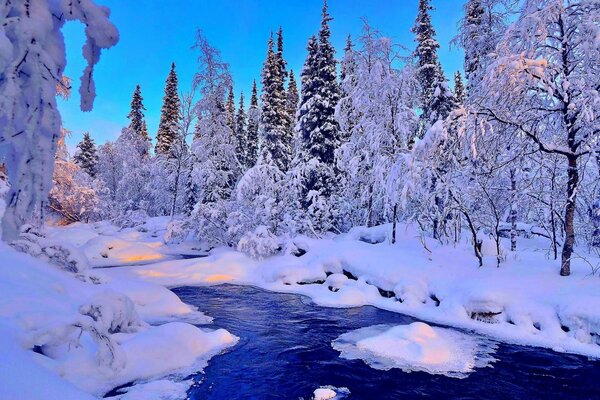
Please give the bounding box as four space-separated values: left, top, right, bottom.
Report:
70 219 600 357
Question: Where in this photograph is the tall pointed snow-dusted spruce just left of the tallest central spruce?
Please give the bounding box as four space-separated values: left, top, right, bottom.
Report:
259 35 291 172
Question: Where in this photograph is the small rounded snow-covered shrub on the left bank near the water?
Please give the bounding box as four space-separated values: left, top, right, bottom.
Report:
79 291 142 334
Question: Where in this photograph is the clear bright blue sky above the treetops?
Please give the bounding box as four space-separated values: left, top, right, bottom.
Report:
59 0 463 149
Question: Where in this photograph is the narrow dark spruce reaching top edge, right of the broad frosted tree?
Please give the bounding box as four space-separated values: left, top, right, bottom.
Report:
412 0 446 137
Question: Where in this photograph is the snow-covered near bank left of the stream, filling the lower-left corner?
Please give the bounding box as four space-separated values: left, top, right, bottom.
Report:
0 220 237 400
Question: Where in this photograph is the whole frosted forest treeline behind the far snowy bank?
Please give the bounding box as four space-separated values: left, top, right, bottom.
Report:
55 0 600 275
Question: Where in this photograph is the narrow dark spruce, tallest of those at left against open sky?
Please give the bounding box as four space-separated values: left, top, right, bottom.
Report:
154 63 181 156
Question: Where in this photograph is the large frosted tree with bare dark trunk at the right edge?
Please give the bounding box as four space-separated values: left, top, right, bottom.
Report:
477 0 600 275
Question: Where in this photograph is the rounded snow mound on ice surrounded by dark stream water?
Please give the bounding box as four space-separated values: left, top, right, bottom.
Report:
332 322 496 378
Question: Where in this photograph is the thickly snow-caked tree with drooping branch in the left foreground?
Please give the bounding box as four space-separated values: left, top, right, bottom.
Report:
0 0 119 240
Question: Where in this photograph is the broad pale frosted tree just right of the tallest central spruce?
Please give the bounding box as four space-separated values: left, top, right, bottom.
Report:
338 24 418 229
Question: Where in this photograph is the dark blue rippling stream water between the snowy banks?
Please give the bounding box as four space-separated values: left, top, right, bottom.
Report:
174 285 600 400
